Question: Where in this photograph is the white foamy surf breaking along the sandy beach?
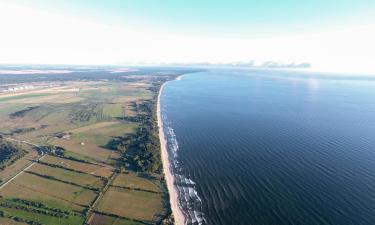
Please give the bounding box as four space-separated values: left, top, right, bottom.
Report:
162 110 207 225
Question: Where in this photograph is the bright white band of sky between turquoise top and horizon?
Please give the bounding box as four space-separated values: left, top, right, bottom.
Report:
0 3 375 73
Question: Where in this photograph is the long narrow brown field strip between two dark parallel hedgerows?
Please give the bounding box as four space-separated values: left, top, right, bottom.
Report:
42 155 113 177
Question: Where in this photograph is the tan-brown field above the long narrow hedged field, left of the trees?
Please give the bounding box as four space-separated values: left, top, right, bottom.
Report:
52 139 113 163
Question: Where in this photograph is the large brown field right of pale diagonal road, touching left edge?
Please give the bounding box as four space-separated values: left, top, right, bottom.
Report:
0 173 96 211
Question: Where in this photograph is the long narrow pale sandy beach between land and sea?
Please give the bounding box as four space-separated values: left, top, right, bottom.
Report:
157 76 185 225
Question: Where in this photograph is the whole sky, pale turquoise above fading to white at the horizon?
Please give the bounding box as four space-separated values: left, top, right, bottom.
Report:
0 0 375 74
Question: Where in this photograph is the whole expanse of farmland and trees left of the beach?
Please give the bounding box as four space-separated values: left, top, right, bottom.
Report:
0 69 195 225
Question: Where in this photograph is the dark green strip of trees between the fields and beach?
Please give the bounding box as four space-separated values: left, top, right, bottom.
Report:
107 81 170 173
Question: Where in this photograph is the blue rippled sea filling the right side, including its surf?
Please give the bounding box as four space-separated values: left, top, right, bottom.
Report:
161 69 375 225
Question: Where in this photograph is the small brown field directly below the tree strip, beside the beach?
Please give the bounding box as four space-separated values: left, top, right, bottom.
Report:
112 172 161 192
